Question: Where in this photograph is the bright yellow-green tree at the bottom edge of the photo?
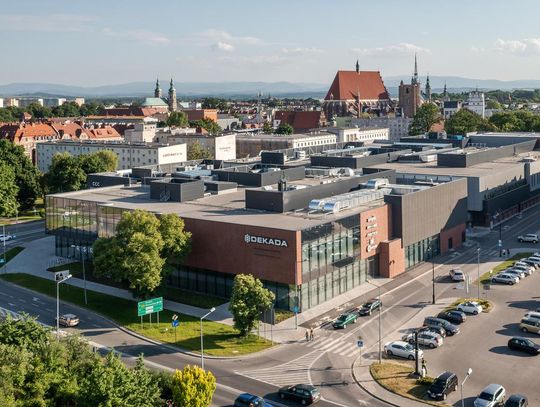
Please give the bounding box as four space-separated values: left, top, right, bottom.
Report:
172 365 216 407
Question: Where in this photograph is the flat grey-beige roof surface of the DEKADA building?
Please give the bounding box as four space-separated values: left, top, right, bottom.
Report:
49 179 385 231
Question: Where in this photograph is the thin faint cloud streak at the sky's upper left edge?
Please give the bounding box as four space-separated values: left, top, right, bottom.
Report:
0 14 95 32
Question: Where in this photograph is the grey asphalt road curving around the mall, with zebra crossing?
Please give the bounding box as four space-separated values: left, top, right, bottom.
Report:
0 209 540 407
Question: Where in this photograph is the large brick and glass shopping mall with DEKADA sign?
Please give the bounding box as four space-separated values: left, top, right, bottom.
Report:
46 156 467 311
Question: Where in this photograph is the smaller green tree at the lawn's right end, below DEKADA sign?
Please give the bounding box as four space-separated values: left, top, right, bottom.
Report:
229 274 275 336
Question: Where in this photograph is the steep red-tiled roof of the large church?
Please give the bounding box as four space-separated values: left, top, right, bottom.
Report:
324 71 390 100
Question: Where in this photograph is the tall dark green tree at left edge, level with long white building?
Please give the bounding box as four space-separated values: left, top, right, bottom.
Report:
0 140 41 209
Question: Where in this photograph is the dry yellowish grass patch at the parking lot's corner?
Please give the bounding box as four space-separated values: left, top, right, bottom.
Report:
369 362 448 406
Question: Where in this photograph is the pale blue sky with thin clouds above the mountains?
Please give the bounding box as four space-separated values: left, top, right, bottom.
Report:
0 0 540 86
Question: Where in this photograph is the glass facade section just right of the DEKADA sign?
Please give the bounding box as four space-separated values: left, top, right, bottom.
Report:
299 215 379 310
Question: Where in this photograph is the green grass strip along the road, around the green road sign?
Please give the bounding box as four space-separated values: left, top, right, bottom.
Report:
1 273 271 356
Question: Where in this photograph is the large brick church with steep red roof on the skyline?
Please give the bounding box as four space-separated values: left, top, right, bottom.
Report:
323 61 394 118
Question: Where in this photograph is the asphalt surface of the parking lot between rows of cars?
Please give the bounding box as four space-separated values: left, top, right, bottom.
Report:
382 250 540 406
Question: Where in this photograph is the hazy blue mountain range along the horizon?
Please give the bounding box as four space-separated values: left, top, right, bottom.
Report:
0 75 540 98
